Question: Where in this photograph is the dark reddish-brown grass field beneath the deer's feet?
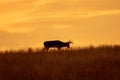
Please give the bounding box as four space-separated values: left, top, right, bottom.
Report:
0 45 120 80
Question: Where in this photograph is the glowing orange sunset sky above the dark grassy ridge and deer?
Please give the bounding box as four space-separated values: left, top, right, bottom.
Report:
0 0 120 49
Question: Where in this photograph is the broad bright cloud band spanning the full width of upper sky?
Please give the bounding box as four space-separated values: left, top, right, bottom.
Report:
0 0 120 26
